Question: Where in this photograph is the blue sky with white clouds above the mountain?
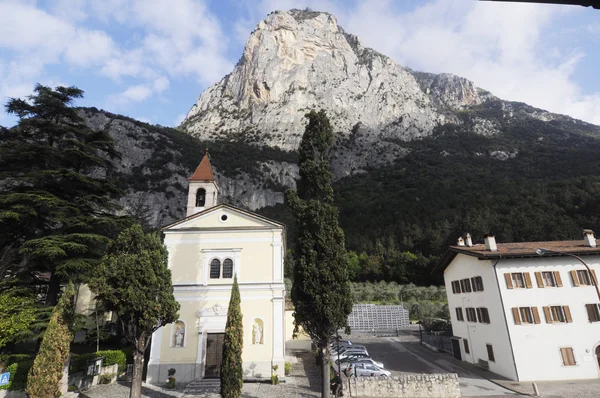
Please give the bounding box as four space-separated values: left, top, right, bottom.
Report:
0 0 600 126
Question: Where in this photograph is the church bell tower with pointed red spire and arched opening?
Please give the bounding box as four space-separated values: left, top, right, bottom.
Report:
186 148 219 217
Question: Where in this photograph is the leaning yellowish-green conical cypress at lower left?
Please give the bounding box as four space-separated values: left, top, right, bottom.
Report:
27 283 75 397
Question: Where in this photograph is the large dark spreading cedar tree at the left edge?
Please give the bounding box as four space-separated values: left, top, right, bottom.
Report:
0 85 122 305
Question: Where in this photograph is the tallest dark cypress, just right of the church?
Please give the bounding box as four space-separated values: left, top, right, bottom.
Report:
286 111 352 397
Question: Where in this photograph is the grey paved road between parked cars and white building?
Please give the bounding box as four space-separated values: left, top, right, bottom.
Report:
353 337 521 397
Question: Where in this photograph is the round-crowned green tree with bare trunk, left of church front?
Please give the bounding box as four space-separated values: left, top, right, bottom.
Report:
90 224 179 398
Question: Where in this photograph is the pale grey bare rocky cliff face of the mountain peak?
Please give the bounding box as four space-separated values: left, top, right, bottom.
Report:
182 10 485 160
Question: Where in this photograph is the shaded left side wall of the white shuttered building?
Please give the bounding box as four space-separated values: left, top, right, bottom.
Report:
444 254 517 380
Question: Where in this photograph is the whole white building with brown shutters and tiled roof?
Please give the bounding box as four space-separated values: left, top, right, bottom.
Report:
437 230 600 381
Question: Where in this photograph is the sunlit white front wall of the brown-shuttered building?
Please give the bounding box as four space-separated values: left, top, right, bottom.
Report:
497 256 600 381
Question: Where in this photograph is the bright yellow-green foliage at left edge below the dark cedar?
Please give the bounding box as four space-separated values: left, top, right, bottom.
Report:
0 289 36 348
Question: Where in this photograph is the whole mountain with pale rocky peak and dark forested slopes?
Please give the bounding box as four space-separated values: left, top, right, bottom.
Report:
82 10 600 283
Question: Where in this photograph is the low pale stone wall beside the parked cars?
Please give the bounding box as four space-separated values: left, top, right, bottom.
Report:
344 373 460 398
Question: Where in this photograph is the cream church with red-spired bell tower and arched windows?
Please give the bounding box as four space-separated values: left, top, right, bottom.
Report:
146 150 290 384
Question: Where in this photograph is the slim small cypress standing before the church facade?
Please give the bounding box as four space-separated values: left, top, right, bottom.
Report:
220 276 244 398
